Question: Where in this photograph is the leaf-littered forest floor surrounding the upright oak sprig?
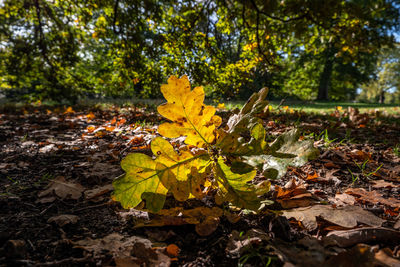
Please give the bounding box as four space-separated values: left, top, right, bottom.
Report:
0 103 400 266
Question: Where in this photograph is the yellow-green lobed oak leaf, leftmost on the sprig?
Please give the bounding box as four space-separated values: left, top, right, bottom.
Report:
113 137 209 212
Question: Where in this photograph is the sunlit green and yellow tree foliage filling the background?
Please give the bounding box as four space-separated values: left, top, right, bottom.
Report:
0 0 400 101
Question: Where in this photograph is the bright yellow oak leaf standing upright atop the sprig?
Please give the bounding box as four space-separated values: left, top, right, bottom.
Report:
157 75 222 147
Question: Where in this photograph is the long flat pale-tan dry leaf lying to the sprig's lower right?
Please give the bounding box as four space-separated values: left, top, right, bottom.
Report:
283 205 384 231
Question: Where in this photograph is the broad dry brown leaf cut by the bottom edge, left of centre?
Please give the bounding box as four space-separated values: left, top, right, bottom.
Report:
72 233 171 267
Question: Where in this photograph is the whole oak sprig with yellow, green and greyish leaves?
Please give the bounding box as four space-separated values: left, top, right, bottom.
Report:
113 76 318 212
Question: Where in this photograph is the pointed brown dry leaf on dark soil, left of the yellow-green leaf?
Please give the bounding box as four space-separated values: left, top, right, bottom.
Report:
38 176 85 200
